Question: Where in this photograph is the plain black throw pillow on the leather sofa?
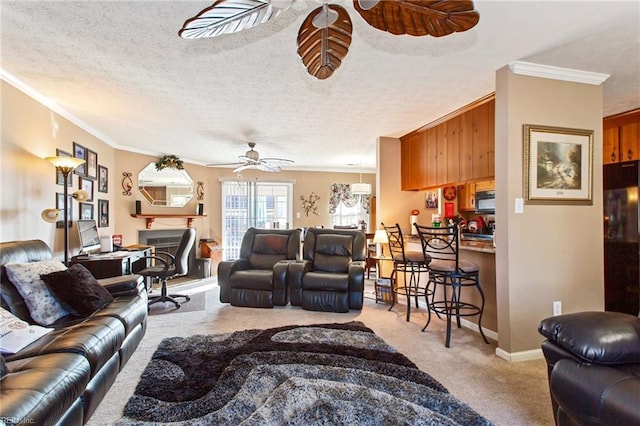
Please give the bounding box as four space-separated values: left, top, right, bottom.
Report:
41 263 113 317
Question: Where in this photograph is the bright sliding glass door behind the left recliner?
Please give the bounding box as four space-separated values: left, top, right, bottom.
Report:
222 181 293 260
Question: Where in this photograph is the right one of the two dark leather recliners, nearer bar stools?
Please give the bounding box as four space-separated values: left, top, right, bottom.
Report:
287 228 366 312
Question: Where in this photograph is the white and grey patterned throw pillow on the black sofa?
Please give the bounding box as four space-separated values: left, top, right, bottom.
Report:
5 260 69 325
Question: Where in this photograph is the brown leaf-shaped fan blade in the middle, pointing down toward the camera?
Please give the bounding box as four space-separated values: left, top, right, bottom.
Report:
298 4 353 80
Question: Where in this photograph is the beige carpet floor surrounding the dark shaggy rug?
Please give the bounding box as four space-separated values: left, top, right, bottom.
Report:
88 279 554 426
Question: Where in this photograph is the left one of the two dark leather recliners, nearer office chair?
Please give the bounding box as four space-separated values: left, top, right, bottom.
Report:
218 228 300 308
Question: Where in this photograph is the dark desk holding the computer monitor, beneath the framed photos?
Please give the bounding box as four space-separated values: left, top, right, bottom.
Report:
71 247 151 288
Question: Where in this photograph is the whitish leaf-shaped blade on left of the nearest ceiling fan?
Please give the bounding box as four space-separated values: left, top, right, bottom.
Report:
178 0 282 39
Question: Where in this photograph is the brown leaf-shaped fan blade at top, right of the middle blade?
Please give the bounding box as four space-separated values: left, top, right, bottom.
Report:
353 0 480 37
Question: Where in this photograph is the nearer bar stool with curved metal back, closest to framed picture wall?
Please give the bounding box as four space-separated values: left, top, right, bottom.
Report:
414 223 489 348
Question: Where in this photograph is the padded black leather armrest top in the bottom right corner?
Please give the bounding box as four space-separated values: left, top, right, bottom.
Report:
538 312 640 365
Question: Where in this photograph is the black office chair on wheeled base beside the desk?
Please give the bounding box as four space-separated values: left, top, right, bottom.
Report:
137 228 196 309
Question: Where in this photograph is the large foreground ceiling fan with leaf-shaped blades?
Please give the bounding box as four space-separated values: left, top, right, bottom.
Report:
178 0 480 80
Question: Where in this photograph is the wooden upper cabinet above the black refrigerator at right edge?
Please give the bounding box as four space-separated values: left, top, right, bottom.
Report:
602 108 640 164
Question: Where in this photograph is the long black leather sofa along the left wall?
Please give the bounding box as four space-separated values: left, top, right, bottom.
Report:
0 240 147 425
